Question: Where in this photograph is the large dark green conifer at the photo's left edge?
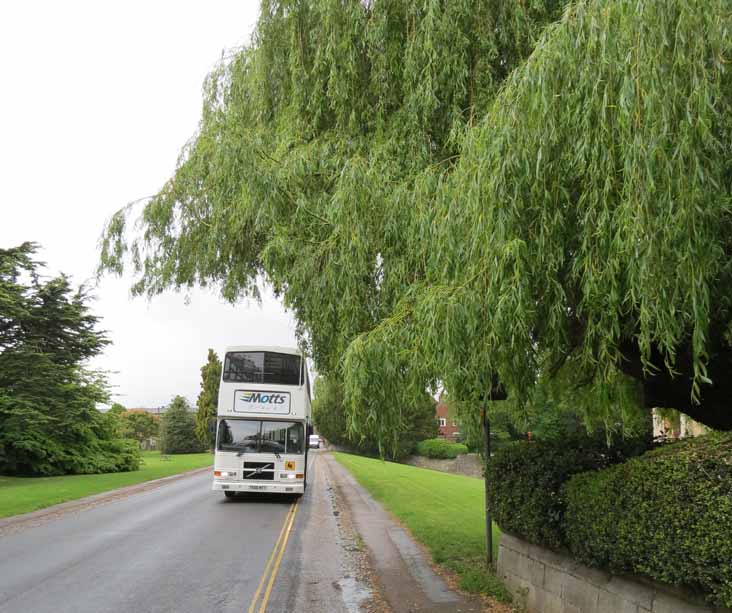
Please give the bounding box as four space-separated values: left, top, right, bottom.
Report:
0 243 140 475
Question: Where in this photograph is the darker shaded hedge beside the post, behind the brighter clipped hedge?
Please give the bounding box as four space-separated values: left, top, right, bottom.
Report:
487 436 648 549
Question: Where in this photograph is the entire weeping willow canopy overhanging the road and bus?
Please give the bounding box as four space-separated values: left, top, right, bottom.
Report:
101 0 732 462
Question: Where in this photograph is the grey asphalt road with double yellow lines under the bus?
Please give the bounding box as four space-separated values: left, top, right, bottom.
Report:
0 453 351 613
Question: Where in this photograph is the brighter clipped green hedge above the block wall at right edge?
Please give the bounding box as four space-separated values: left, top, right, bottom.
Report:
564 434 732 607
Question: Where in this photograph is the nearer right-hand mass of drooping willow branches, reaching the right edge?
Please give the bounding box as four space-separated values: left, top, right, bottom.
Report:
346 0 732 429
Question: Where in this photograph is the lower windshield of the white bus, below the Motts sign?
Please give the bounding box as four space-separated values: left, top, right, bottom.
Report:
217 419 305 453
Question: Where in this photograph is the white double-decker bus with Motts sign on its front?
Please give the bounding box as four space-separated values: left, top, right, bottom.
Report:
213 346 311 498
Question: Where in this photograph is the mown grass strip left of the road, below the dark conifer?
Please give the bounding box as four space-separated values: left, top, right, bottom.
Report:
0 451 213 517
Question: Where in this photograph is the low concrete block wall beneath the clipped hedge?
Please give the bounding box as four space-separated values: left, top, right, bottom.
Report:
498 534 732 613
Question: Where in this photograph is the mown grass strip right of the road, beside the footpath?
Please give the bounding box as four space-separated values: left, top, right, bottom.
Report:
335 453 510 601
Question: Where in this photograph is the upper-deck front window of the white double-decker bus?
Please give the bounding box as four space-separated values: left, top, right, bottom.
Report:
223 351 300 385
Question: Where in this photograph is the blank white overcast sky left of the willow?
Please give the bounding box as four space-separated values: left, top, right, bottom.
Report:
0 0 302 407
